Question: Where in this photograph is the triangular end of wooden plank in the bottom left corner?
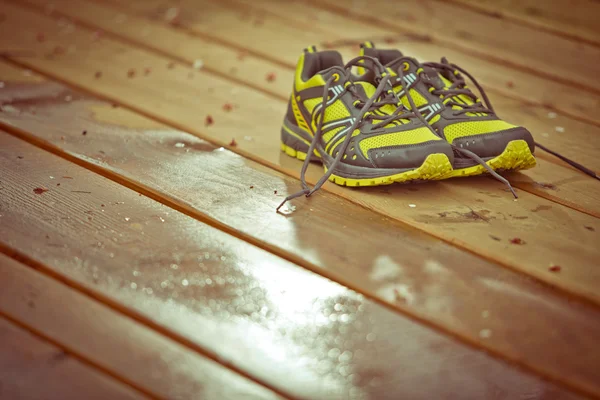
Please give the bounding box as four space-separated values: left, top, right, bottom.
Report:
0 318 147 400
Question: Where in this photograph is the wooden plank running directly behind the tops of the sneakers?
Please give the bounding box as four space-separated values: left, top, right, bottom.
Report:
108 0 600 126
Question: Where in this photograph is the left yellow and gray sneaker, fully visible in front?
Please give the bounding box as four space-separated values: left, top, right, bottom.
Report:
281 46 453 209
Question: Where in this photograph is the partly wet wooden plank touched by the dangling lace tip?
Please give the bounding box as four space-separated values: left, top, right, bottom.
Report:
0 65 600 396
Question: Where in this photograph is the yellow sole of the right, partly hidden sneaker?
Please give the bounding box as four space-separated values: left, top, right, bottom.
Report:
444 140 537 178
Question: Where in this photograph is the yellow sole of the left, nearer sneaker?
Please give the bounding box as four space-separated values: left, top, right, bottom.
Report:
281 143 452 187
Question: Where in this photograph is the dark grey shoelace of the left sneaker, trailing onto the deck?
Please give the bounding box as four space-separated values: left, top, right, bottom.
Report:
276 56 415 211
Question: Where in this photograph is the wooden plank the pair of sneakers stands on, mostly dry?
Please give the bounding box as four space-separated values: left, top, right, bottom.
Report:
0 5 600 301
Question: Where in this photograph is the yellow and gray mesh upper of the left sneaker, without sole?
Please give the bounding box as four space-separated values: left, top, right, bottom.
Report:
284 51 452 168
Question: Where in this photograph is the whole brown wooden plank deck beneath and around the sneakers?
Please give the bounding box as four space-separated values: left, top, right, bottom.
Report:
0 0 600 400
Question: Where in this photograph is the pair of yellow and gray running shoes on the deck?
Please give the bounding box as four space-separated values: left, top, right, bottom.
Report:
281 42 536 208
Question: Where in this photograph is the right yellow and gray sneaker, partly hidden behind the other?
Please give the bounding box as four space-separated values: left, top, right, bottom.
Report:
359 42 536 182
